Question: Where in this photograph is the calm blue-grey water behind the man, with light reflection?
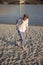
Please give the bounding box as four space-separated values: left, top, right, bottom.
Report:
0 5 43 25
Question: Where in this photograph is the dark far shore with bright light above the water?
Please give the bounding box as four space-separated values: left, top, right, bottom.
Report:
0 0 43 5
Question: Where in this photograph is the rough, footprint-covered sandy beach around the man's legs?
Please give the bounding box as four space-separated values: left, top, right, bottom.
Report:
0 24 43 65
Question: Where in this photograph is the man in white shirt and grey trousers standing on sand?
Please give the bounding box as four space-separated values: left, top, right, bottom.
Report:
17 14 29 48
